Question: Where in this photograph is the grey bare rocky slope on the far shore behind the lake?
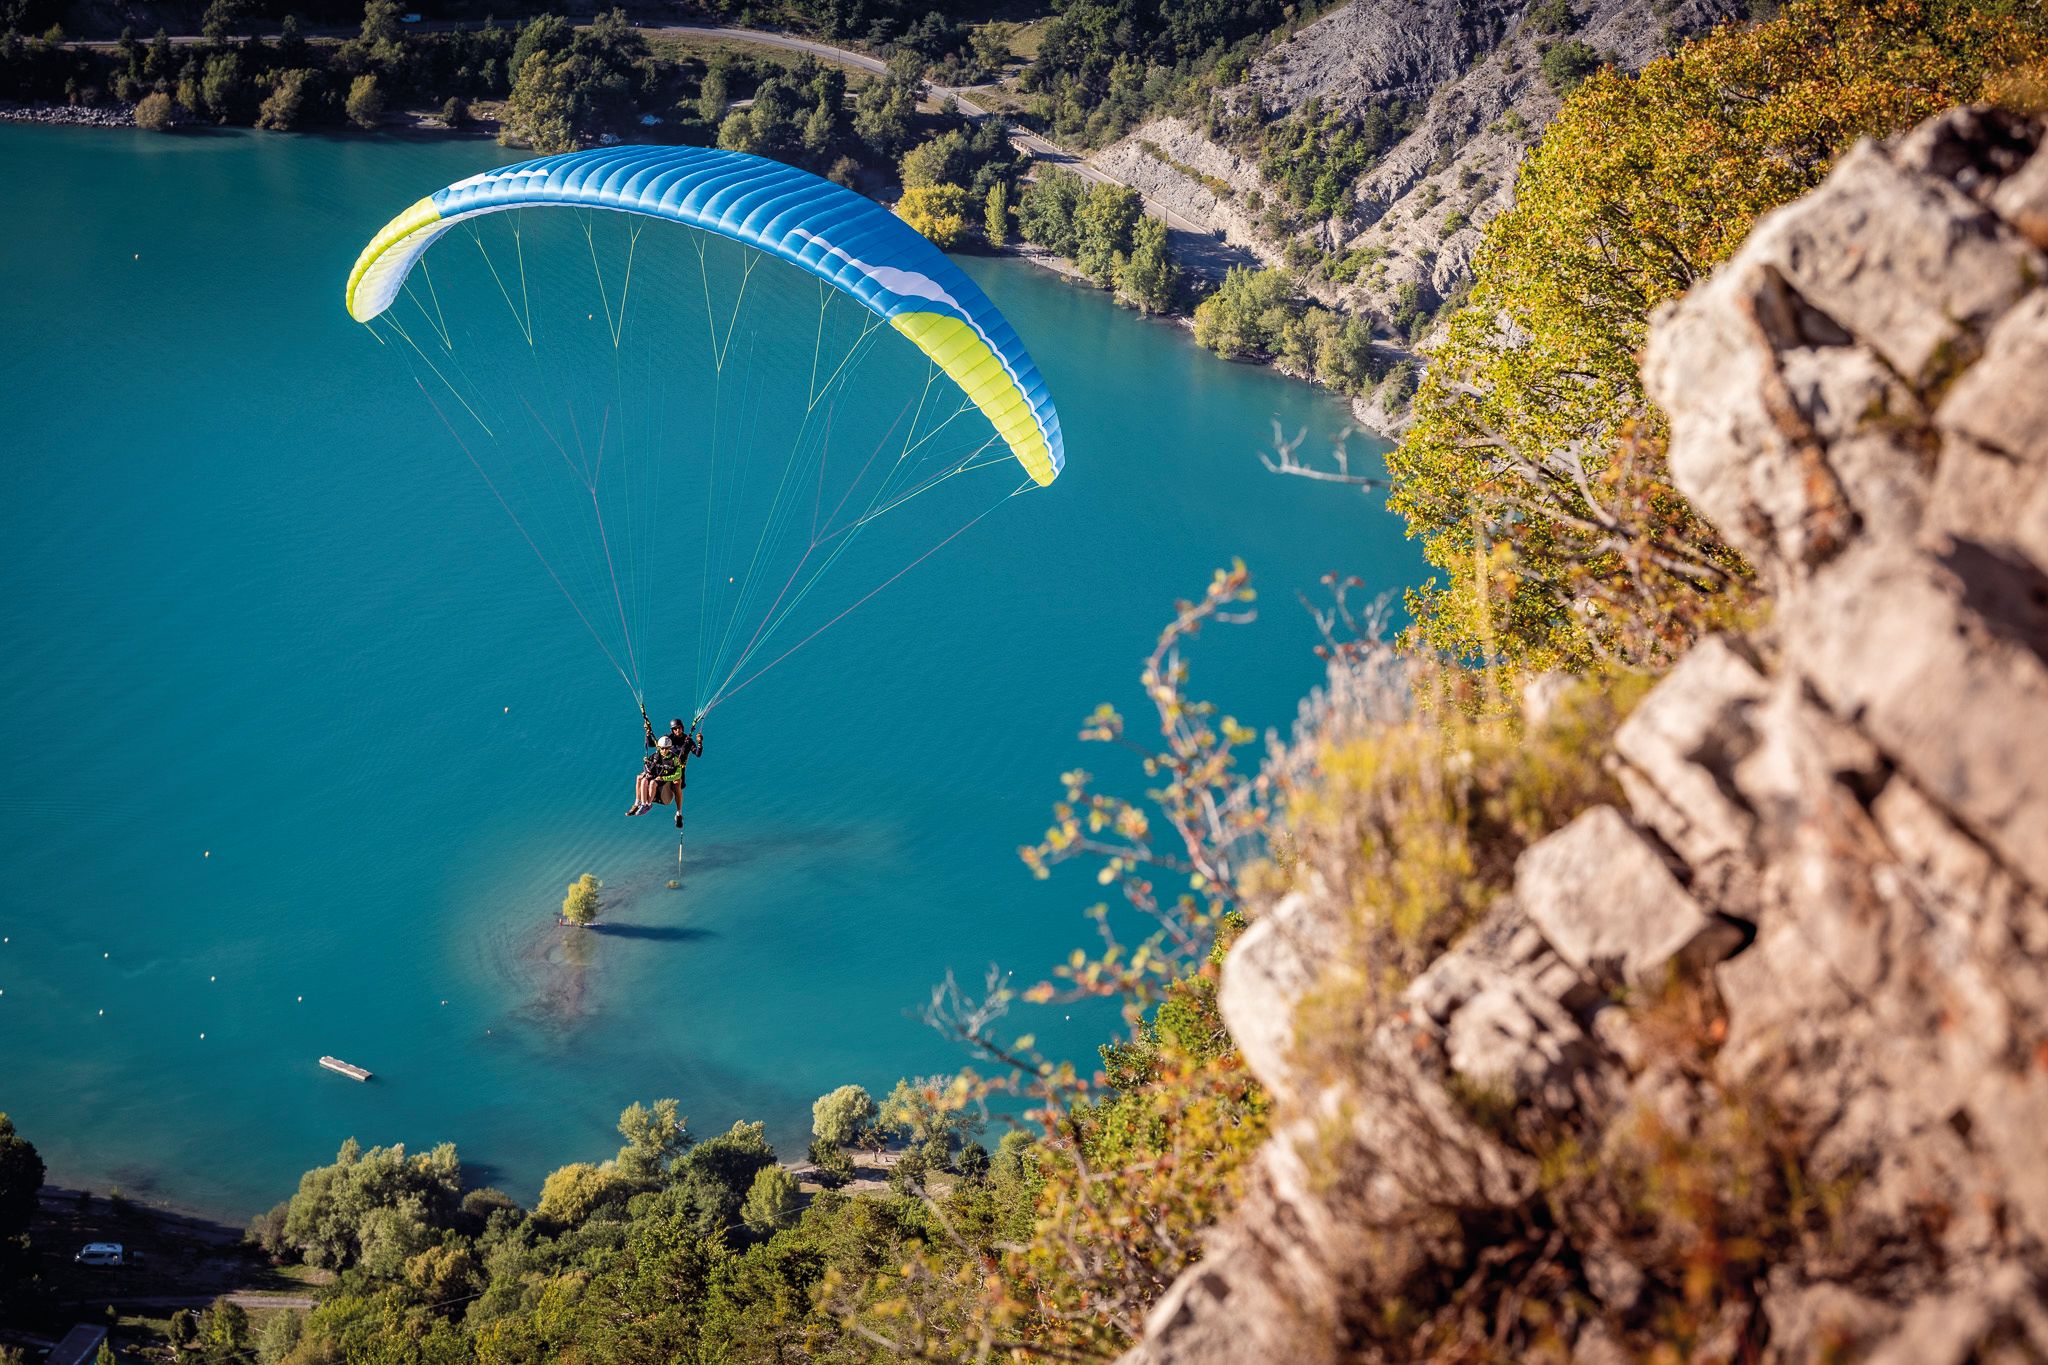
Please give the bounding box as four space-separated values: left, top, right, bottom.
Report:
1092 0 1745 421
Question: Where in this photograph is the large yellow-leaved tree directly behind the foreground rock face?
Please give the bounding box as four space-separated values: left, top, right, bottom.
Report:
1389 0 2048 671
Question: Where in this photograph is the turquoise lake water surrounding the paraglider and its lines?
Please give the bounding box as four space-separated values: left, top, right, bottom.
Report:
0 125 1419 1218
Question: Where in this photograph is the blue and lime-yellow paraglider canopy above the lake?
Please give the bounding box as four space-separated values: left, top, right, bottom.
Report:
346 145 1065 485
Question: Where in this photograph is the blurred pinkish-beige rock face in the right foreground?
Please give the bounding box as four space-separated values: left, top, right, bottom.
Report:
1128 111 2048 1365
